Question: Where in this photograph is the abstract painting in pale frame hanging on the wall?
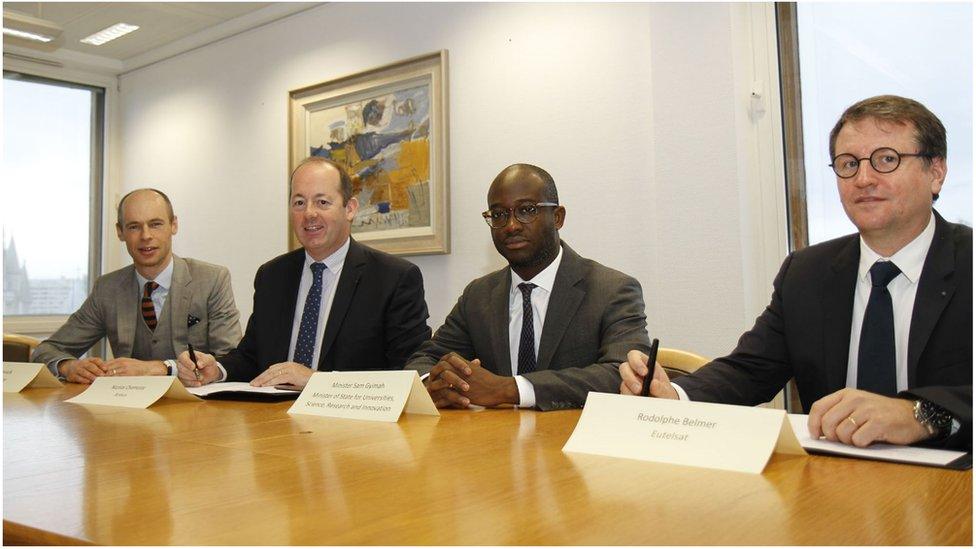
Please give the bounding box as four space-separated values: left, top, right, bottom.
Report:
288 50 451 255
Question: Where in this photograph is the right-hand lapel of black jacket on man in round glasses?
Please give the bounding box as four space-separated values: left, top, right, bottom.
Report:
908 213 956 388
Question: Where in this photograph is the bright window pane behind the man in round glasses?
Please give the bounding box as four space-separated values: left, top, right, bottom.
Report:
796 2 973 244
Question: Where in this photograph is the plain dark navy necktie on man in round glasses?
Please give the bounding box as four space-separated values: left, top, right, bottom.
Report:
857 261 901 396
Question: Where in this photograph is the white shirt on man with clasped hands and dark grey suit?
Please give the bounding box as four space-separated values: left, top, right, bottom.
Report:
508 246 563 408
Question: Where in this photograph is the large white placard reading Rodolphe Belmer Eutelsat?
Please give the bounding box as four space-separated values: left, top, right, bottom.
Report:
563 392 806 473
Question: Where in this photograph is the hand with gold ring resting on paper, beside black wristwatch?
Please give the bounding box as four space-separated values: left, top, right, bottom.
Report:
807 389 929 448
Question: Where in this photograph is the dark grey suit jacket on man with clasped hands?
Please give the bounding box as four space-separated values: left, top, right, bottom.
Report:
406 243 650 410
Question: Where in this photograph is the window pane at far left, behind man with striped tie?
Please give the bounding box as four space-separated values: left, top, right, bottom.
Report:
3 77 93 316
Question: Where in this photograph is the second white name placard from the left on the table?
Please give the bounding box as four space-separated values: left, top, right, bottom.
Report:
65 376 200 408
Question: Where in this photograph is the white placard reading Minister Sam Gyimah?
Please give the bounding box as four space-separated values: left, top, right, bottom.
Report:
288 370 441 422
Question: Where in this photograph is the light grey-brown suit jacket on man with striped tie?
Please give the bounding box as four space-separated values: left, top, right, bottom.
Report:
31 255 241 363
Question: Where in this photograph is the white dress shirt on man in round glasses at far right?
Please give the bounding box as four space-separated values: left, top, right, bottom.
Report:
672 215 935 400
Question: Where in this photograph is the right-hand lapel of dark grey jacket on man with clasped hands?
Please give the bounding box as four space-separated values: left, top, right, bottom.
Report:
536 244 586 370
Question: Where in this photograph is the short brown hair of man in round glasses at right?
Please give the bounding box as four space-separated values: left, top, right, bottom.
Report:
830 95 947 200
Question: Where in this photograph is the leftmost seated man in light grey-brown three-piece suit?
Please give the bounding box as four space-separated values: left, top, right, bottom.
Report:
31 189 241 383
